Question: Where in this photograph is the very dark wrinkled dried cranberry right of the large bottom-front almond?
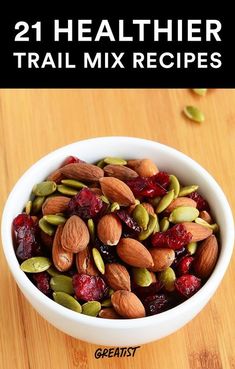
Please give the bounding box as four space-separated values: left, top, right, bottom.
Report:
143 293 170 315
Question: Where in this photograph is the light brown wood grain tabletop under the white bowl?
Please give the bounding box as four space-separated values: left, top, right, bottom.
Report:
0 90 235 369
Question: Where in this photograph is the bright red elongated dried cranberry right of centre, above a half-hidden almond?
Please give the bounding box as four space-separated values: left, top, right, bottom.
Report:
151 224 192 250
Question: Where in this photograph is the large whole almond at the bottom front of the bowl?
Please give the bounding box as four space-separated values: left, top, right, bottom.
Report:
111 290 145 319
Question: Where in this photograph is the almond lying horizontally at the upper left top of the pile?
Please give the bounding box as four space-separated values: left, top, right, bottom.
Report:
60 163 104 182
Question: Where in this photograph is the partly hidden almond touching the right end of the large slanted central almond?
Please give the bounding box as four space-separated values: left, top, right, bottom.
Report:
149 248 175 272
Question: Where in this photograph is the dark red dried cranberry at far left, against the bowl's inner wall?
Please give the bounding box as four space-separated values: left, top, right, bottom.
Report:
13 214 41 260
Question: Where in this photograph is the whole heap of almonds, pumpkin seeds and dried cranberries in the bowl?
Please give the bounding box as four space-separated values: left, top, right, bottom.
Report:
13 156 219 319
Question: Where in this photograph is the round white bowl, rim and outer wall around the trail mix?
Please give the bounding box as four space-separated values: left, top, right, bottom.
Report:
2 137 234 346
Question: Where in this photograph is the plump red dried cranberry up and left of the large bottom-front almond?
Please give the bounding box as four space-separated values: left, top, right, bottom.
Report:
73 274 107 301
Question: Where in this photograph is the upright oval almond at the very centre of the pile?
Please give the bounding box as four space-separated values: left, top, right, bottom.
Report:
97 214 122 246
